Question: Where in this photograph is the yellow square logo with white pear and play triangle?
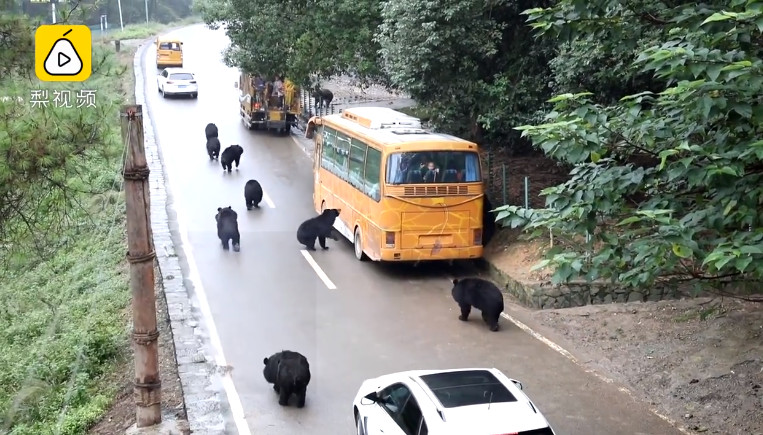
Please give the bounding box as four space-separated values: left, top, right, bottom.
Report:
35 24 92 82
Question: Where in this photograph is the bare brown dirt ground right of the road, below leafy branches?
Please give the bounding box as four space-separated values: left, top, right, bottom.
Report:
488 231 763 435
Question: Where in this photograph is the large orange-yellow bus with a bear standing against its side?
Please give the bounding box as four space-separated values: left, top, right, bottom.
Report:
305 107 484 262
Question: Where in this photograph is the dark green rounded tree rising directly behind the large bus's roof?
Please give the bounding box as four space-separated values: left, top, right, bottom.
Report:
377 0 554 147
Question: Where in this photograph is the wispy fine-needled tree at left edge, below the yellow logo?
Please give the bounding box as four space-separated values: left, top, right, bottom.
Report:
0 11 122 269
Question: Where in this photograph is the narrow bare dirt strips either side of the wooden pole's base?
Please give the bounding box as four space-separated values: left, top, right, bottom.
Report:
88 269 190 435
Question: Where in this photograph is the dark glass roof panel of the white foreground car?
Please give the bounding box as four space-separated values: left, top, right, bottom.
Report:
421 370 517 408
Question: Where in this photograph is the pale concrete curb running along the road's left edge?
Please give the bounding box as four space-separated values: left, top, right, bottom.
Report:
133 29 226 434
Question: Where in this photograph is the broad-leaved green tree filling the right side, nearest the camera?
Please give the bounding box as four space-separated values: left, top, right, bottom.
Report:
497 0 763 288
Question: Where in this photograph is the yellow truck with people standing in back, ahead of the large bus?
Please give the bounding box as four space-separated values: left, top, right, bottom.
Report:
235 73 302 134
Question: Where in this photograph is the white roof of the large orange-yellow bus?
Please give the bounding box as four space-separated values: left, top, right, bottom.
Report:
321 107 476 147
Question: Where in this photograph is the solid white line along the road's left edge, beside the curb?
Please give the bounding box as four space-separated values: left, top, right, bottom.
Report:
177 192 252 435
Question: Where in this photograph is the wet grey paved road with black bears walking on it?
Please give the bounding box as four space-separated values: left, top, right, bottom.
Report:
144 26 678 435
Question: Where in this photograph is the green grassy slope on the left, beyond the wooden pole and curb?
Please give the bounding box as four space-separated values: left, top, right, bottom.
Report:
0 20 182 435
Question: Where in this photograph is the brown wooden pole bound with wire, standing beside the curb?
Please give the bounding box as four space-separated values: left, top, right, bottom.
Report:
120 105 162 428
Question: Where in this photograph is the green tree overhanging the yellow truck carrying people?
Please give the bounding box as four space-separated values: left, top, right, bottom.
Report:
195 0 381 85
